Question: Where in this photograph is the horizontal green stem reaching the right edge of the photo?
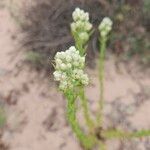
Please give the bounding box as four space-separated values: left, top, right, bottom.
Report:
103 130 150 139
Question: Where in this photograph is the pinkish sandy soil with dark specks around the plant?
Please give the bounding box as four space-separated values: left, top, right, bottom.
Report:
0 0 150 150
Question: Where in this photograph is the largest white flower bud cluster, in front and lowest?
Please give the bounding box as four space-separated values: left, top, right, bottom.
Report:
53 46 89 91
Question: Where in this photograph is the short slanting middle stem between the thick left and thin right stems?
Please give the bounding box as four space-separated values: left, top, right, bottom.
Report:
79 87 94 132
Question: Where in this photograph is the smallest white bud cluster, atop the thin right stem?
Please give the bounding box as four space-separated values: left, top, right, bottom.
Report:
98 17 113 37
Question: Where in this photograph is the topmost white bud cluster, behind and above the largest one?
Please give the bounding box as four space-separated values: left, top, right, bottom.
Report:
71 8 92 45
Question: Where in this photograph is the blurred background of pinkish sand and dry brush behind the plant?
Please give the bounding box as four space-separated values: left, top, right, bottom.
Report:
0 0 150 150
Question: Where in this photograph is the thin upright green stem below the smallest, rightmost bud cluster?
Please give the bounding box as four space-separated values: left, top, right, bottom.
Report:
97 37 107 126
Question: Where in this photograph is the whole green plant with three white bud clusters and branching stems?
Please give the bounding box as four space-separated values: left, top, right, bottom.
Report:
53 8 150 150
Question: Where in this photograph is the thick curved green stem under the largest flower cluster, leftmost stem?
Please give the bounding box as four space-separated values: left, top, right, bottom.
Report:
66 89 95 150
